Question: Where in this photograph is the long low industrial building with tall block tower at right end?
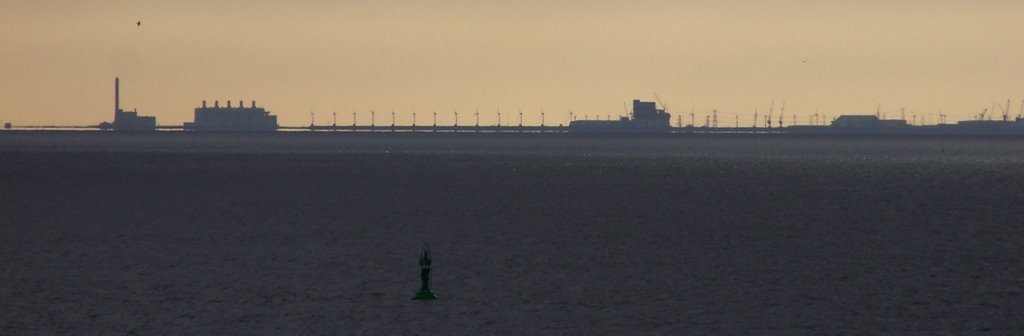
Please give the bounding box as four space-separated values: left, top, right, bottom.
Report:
569 99 672 132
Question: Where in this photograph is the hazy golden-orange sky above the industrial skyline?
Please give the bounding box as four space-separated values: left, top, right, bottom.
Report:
0 0 1024 126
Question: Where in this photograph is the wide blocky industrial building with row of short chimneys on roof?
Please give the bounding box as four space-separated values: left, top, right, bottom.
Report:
183 100 278 131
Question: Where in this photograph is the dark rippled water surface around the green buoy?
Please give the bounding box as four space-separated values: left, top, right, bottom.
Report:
0 132 1024 335
